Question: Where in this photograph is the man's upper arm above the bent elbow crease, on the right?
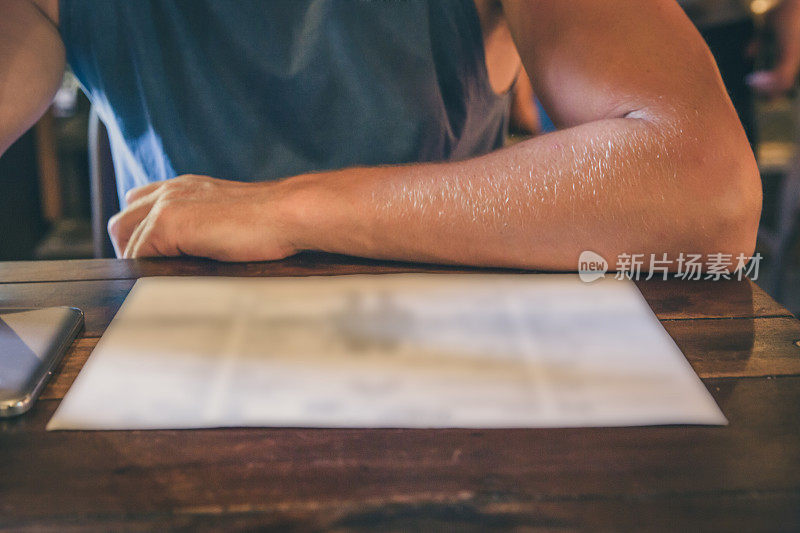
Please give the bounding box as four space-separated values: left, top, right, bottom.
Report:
503 0 730 126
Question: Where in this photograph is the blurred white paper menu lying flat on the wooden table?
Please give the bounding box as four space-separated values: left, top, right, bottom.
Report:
47 274 727 430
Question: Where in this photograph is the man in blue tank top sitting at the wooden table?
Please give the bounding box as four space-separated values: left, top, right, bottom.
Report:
0 0 761 270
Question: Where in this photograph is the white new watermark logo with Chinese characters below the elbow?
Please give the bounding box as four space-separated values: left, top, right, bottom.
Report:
578 250 761 283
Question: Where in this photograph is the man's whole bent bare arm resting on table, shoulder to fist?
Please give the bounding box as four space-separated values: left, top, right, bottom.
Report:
111 0 761 270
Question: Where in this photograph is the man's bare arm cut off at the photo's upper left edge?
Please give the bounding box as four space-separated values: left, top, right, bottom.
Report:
0 0 65 154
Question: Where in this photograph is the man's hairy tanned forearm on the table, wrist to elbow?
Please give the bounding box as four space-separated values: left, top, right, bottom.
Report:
284 112 760 270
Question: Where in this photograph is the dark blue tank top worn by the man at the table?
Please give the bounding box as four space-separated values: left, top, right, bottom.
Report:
59 0 508 204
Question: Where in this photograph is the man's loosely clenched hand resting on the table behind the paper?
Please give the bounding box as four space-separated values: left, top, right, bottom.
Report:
108 175 297 261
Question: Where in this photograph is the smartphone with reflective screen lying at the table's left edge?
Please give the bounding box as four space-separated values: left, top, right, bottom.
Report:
0 307 83 418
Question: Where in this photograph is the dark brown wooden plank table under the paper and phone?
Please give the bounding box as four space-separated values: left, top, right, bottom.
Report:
0 254 800 531
